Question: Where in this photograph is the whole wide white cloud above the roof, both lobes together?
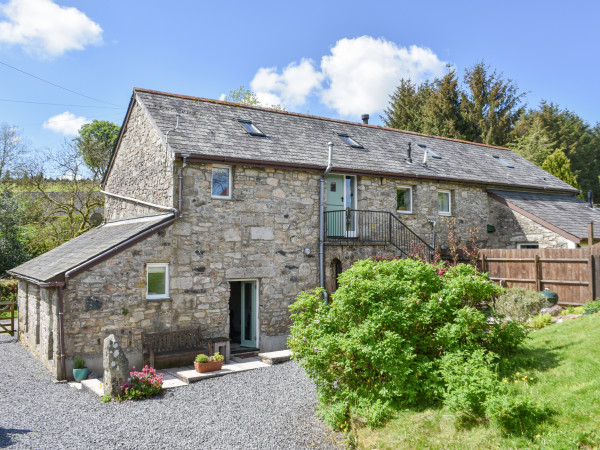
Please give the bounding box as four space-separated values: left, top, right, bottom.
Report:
250 36 446 116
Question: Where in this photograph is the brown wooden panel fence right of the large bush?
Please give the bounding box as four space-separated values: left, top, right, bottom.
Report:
480 245 600 305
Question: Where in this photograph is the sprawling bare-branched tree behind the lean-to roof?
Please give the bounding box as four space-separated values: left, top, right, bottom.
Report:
21 141 104 254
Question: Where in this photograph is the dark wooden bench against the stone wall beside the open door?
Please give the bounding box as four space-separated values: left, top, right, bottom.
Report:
142 327 210 367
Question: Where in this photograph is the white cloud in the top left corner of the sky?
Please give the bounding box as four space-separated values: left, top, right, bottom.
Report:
0 0 102 57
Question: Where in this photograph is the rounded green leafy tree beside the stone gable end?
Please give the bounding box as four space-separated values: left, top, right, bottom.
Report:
73 120 121 179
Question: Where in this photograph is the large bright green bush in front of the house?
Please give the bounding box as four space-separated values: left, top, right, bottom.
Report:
288 259 525 429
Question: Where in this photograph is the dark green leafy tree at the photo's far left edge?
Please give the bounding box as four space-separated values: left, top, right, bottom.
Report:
0 188 31 276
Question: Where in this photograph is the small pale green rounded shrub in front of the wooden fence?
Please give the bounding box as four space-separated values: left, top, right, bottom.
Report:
494 287 548 323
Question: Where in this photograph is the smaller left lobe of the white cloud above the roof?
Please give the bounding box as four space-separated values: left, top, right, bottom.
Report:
250 59 323 107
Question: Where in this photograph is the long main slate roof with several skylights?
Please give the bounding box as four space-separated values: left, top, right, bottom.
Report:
134 88 577 193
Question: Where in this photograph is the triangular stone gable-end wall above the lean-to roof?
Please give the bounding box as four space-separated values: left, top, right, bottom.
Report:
104 102 175 222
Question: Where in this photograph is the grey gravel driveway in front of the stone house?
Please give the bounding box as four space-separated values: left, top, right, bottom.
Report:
0 334 343 449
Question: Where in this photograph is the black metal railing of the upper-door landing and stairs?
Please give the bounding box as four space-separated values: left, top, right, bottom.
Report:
325 209 434 261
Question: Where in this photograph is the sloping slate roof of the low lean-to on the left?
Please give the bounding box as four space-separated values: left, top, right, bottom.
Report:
8 214 173 282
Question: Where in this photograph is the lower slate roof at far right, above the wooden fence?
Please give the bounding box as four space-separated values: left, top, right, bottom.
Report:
488 190 600 239
